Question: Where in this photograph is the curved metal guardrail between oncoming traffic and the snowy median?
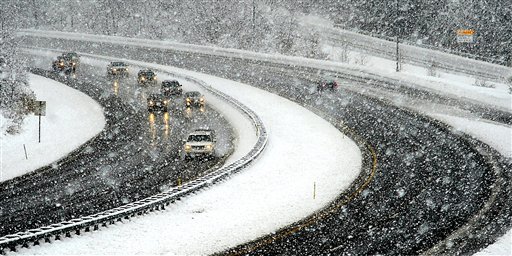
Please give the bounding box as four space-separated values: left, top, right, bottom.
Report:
0 59 268 254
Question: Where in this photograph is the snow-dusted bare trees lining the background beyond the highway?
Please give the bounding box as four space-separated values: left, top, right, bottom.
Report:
0 0 512 63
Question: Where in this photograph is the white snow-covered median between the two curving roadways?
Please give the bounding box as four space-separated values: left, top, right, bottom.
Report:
13 55 362 255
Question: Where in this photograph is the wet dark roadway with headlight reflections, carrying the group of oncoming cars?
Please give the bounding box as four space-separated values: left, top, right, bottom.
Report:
0 62 233 236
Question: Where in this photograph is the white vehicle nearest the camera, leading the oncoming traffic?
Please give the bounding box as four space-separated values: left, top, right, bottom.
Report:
183 129 217 159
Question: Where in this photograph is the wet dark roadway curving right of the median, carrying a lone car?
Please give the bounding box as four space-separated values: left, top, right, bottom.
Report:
16 35 512 255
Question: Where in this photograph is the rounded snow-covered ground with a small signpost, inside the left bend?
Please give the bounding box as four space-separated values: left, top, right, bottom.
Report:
0 75 105 181
